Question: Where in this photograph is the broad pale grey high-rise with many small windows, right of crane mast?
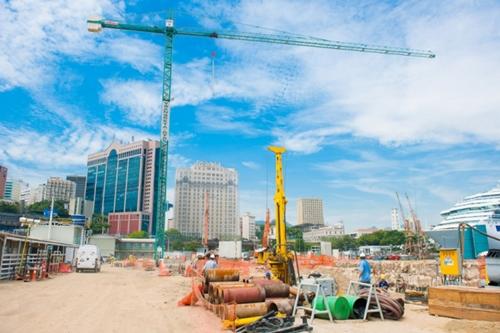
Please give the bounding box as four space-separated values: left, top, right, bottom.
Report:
174 162 240 239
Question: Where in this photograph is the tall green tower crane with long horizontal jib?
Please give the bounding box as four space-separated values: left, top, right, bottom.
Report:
87 17 435 259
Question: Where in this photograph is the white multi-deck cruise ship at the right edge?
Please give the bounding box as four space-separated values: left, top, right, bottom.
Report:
427 185 500 257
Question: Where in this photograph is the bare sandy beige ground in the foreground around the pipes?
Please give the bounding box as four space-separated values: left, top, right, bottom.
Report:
0 265 500 333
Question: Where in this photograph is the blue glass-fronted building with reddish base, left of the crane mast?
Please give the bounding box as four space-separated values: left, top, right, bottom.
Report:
85 140 160 235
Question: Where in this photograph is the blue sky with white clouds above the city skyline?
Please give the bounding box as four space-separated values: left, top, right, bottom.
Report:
0 0 500 230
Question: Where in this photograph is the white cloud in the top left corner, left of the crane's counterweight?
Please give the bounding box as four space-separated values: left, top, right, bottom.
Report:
0 0 124 91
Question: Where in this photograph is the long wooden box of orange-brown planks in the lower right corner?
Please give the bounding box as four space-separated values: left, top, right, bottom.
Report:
429 286 500 321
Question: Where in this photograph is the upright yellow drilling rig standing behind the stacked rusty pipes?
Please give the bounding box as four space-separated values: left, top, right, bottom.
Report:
257 146 297 285
